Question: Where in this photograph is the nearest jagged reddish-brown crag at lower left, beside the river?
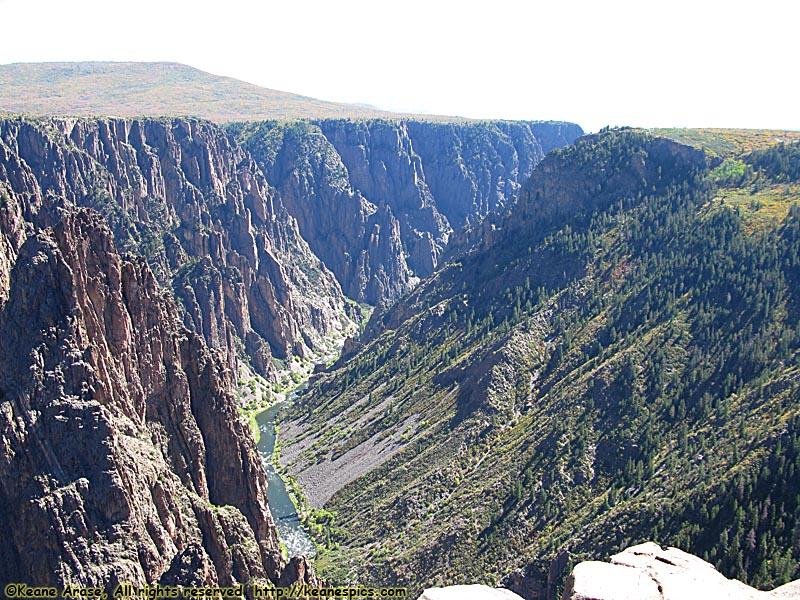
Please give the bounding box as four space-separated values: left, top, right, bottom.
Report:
0 211 311 591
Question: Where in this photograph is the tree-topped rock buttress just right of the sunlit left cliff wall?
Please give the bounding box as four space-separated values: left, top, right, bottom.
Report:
227 121 413 304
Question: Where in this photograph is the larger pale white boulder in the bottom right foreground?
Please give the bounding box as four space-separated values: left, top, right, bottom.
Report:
562 542 800 600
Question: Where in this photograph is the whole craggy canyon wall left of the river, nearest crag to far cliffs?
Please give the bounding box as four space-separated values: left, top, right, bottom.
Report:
0 102 580 591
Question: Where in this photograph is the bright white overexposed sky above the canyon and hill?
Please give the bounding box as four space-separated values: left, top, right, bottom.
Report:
0 0 800 131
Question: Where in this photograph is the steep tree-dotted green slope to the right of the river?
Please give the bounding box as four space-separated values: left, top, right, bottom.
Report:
289 130 800 589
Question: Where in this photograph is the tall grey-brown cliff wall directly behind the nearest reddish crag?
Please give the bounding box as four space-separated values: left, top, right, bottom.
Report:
0 118 348 374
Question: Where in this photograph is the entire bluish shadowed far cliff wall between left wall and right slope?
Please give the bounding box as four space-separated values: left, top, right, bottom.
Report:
229 120 582 304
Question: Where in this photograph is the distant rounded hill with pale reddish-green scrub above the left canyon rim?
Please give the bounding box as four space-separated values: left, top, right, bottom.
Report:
0 62 462 122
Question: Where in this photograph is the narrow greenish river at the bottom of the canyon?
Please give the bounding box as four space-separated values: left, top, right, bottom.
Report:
256 402 315 556
